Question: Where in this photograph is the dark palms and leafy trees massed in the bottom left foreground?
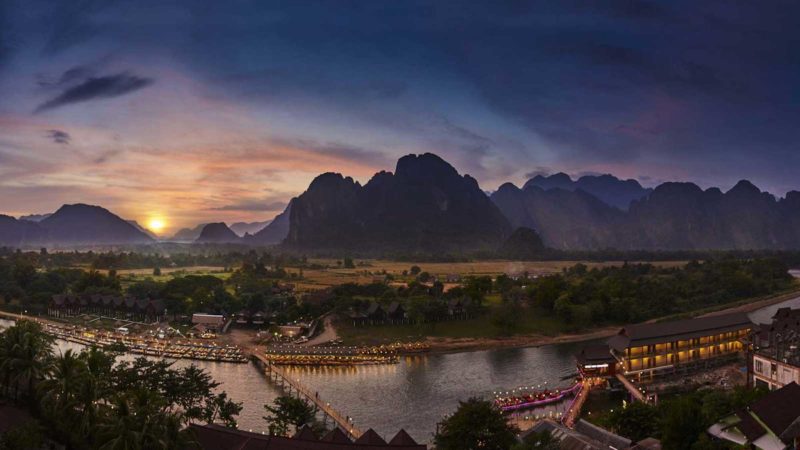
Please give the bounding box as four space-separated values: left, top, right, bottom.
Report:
0 322 241 449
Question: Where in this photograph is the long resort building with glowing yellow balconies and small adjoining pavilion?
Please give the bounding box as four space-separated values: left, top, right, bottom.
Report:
577 313 753 381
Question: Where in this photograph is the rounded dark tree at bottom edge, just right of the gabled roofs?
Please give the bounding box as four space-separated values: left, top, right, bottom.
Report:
433 398 519 450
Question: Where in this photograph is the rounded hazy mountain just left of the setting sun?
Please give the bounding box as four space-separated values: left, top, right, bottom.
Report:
38 204 153 245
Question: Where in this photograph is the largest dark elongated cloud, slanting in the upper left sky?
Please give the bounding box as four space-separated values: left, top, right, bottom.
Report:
34 72 153 113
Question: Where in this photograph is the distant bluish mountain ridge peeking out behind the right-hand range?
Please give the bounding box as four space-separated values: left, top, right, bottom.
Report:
522 173 653 210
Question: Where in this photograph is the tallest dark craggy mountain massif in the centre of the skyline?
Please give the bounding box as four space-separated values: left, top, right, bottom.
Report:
285 153 511 253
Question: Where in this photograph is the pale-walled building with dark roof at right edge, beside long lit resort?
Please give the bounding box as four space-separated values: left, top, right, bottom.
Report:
750 308 800 390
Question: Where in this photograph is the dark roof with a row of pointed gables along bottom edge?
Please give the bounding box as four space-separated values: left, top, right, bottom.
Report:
189 424 426 450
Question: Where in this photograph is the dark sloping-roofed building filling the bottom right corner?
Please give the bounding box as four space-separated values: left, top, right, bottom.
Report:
708 383 800 450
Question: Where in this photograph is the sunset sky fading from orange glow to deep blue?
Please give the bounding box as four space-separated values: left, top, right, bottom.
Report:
0 0 800 235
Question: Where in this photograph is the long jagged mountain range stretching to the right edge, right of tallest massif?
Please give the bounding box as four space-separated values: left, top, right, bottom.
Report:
492 180 800 250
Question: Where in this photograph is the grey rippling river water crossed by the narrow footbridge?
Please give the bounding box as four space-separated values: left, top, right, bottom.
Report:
0 297 800 442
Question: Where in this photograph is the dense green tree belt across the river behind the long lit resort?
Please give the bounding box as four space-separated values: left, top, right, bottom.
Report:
526 259 791 328
